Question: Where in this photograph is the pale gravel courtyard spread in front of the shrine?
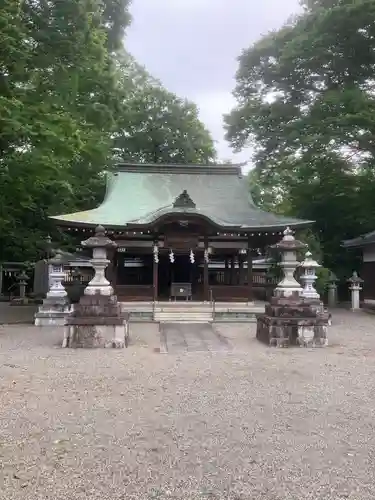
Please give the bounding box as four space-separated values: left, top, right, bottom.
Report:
0 312 375 500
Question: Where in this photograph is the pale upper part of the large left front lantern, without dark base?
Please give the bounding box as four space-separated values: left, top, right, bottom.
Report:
82 226 116 295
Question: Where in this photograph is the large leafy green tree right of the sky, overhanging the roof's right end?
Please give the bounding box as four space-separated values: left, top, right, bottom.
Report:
225 0 375 269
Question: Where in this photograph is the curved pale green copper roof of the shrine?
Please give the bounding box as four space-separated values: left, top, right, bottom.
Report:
52 164 312 230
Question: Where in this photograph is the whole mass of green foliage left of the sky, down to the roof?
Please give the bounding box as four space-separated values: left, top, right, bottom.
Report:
0 0 214 261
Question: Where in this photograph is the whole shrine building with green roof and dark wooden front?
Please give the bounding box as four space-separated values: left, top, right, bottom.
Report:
52 163 312 301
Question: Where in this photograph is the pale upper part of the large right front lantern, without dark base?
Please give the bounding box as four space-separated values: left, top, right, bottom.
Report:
275 227 307 297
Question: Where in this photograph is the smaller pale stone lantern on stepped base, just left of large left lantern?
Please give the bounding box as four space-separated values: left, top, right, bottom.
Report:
34 253 70 326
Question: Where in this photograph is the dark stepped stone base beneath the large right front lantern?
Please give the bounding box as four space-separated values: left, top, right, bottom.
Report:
256 294 328 347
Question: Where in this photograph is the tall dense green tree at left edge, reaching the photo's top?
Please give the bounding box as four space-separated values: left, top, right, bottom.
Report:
0 0 131 260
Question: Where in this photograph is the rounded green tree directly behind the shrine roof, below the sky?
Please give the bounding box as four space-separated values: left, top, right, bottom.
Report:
115 53 216 164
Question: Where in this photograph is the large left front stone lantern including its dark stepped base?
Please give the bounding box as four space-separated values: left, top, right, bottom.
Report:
63 226 129 348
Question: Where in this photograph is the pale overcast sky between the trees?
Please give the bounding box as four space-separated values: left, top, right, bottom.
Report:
126 0 298 168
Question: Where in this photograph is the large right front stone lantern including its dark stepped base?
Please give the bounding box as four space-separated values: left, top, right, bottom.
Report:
256 228 328 347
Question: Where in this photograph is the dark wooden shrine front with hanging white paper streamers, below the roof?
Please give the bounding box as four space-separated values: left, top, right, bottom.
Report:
67 217 282 302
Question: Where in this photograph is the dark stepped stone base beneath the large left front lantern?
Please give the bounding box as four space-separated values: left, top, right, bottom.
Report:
63 294 128 348
